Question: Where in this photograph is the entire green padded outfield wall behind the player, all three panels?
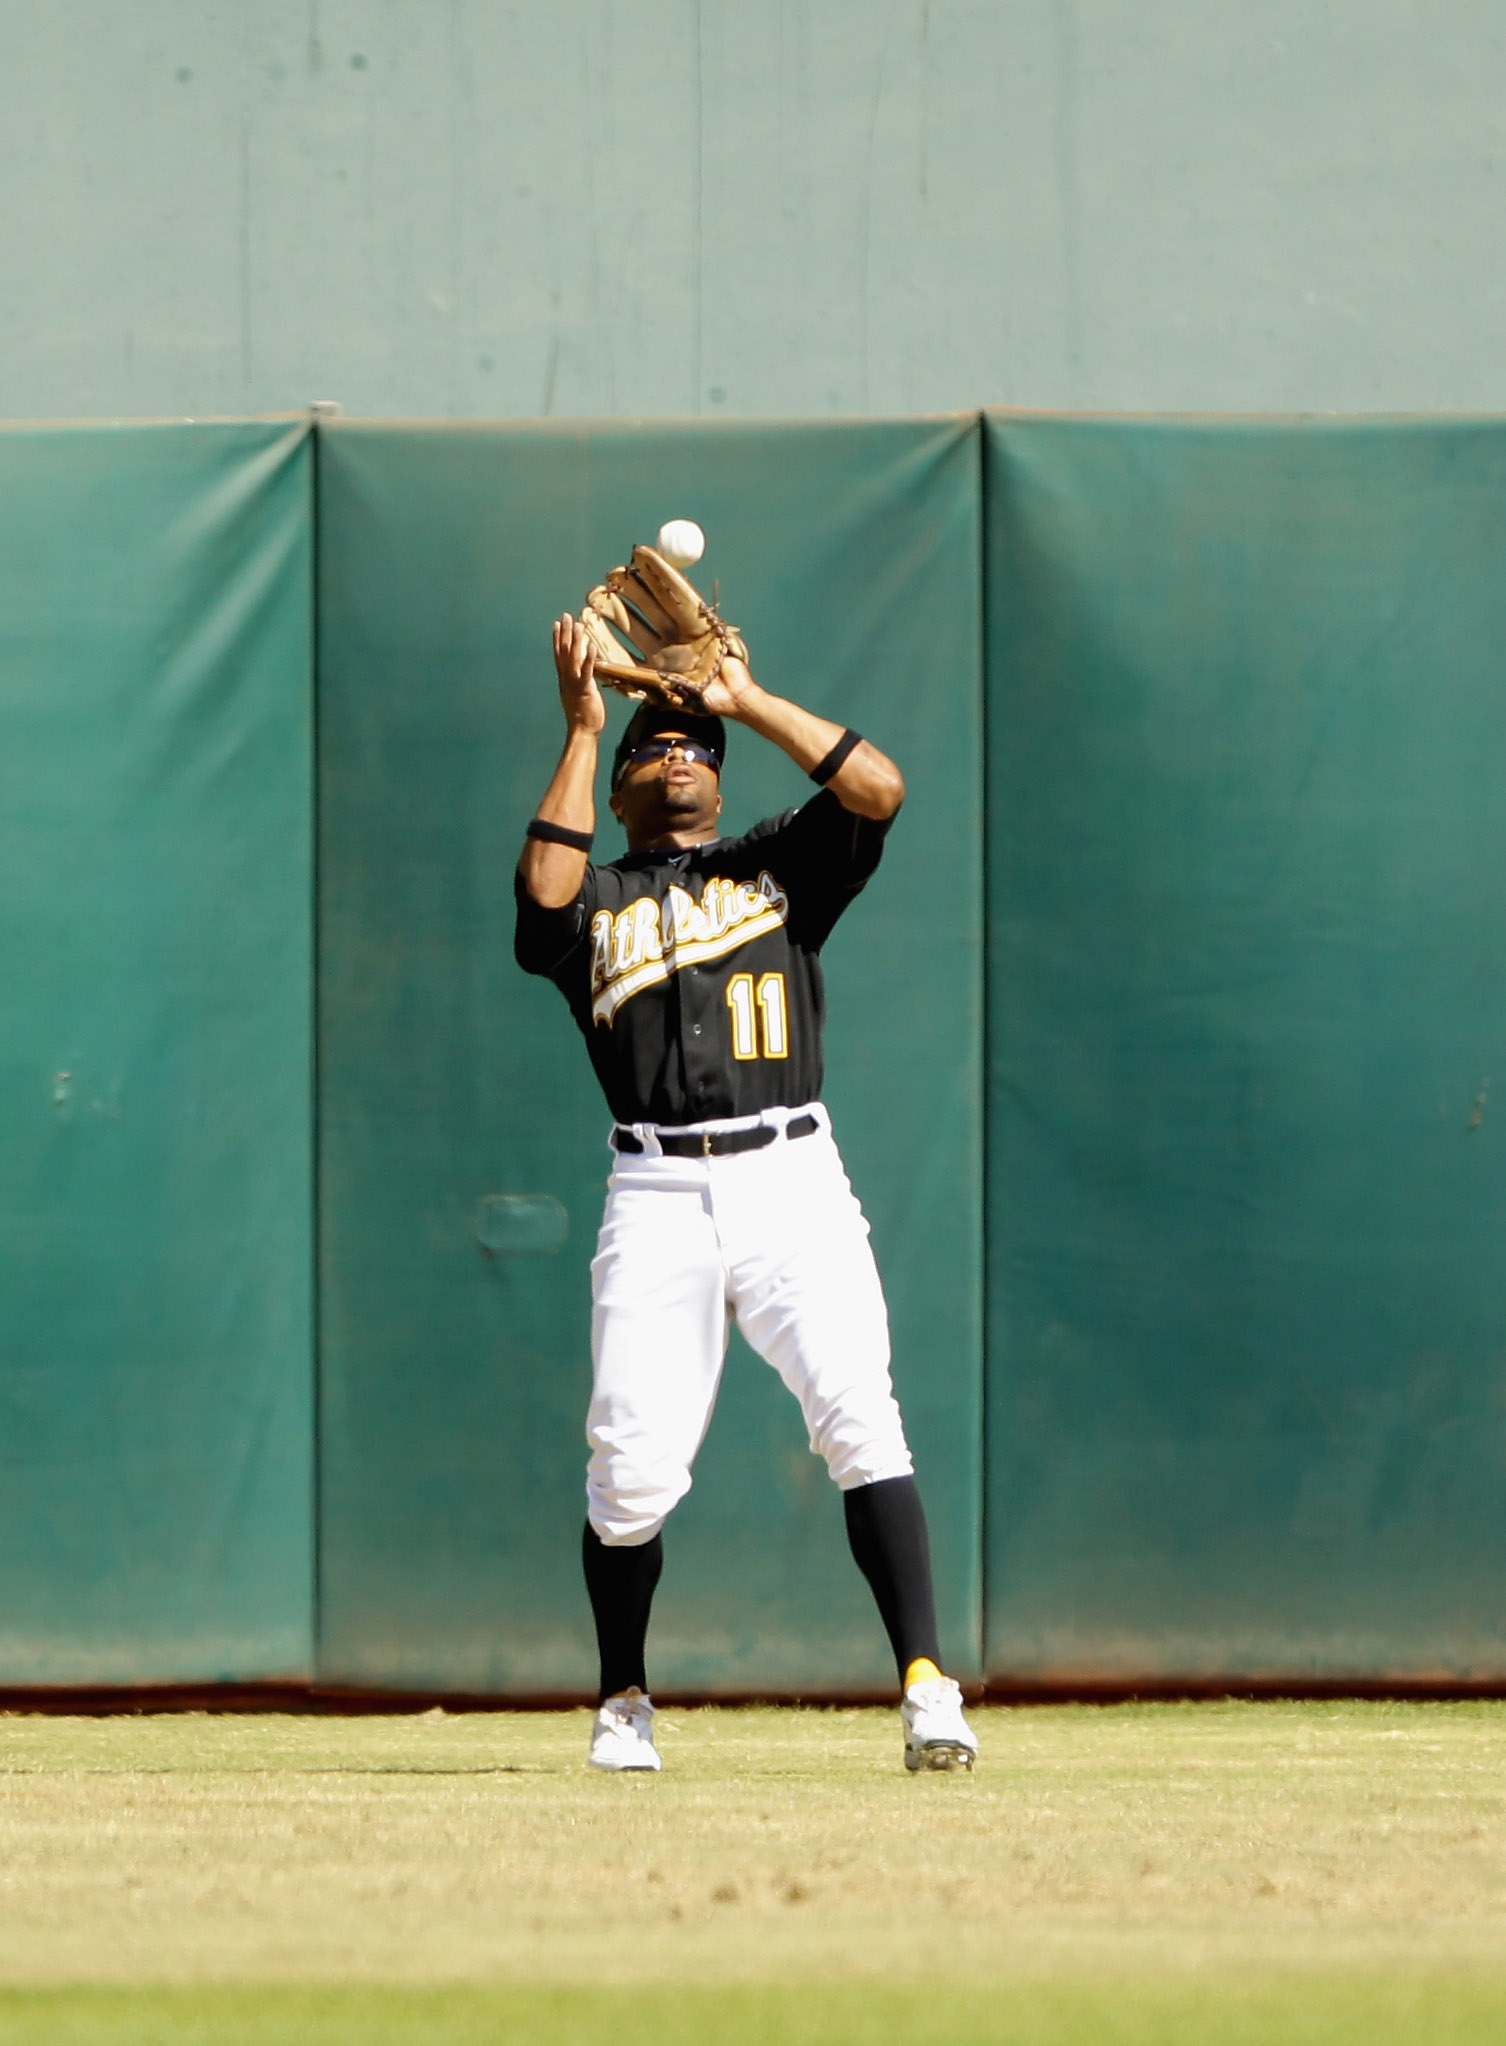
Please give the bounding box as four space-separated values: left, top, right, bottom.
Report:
0 413 1506 1696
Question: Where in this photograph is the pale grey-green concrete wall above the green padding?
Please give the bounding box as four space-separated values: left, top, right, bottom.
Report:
0 0 1506 417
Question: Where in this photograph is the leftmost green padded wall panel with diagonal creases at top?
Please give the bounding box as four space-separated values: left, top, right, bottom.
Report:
0 424 313 1686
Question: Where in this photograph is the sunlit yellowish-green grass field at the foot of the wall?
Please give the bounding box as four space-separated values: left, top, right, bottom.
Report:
0 1704 1506 2046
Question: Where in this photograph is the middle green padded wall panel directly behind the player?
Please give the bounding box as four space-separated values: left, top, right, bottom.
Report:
319 417 982 1694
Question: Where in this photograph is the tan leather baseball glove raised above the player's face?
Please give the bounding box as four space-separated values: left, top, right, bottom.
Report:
581 546 747 710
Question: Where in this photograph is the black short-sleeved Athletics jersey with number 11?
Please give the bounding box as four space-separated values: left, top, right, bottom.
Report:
516 790 888 1127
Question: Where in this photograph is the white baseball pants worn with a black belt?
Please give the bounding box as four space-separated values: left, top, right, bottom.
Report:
585 1103 913 1547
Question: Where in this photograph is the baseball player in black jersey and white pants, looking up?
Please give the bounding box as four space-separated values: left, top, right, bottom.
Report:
518 614 978 1770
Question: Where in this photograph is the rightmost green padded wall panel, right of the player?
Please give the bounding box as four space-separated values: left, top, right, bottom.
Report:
986 417 1506 1682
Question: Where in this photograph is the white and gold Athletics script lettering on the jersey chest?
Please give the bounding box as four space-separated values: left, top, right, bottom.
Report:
591 874 790 1023
